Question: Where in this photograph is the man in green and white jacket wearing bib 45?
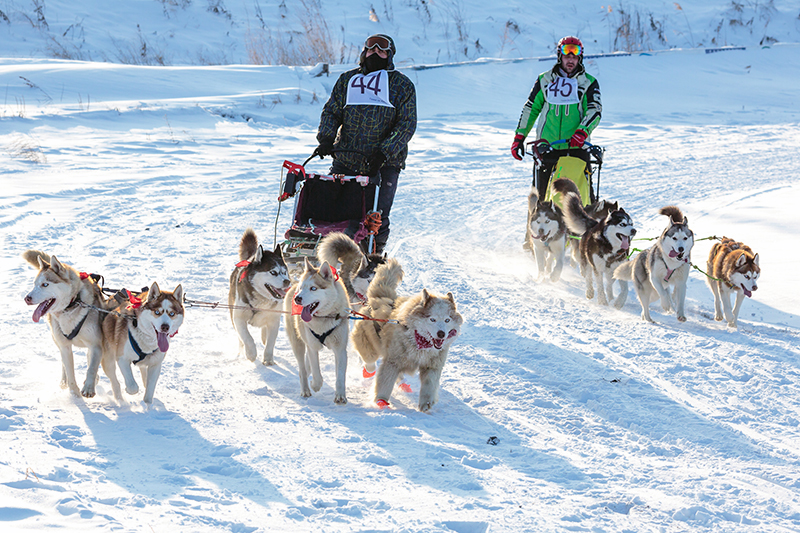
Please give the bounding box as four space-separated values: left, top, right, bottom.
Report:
511 37 602 199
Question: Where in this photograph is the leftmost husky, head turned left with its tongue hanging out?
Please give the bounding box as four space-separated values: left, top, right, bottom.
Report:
22 250 111 398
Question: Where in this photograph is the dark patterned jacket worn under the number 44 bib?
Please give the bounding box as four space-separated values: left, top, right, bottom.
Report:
317 68 417 174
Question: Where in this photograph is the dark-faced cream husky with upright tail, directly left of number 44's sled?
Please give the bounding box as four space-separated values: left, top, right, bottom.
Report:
228 228 291 365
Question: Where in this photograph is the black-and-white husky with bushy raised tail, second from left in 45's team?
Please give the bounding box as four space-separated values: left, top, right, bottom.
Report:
564 193 636 309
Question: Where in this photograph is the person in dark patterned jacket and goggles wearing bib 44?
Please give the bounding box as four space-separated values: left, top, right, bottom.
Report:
315 34 417 253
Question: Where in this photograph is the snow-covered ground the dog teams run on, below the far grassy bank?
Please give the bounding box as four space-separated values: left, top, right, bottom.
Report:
0 4 800 533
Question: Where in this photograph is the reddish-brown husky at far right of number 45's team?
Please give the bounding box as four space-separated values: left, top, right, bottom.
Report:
706 237 761 328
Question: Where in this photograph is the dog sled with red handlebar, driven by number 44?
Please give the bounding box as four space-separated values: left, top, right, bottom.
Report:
278 154 381 269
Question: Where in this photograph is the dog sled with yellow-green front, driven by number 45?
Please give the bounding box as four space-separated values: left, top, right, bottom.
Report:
528 139 604 207
